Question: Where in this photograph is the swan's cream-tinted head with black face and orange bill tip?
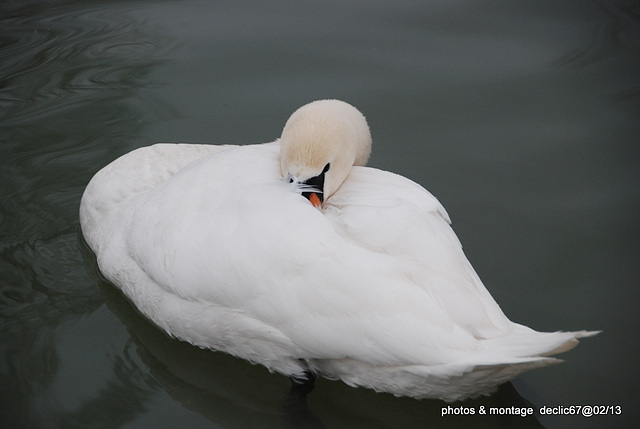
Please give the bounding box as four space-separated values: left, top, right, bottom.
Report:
280 100 371 207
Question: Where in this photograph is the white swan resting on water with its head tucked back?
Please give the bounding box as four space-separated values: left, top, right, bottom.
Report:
79 100 598 401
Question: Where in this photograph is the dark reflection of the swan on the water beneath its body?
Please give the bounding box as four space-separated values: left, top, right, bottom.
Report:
84 241 542 428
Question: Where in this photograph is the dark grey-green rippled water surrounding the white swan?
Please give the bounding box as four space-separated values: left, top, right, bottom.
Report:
0 0 640 428
